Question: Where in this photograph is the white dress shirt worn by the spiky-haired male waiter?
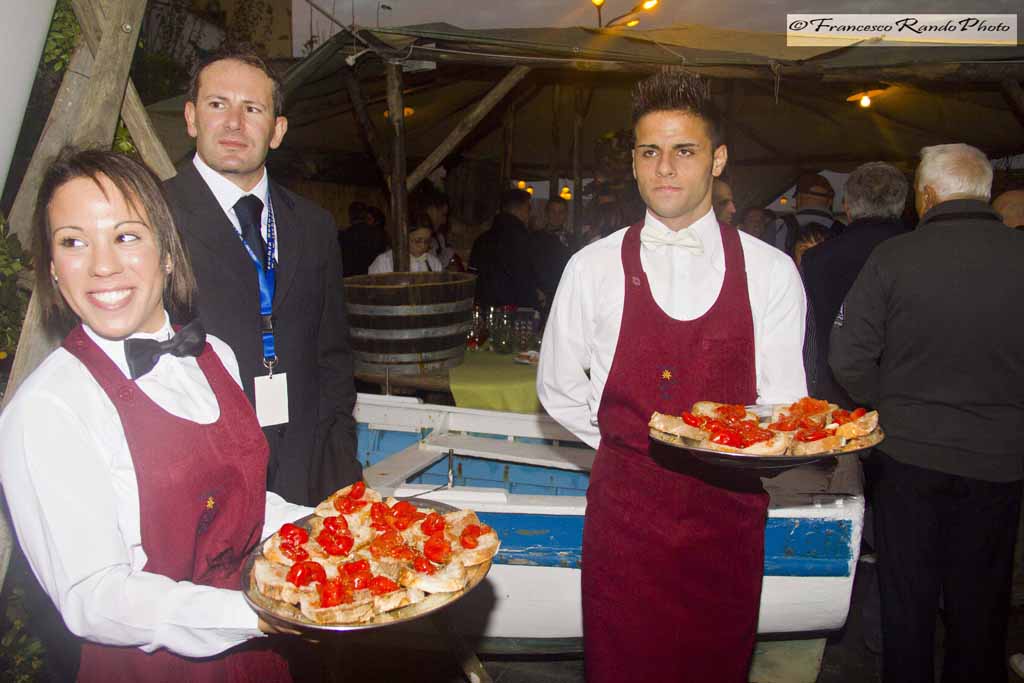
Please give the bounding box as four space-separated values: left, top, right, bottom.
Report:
537 211 807 449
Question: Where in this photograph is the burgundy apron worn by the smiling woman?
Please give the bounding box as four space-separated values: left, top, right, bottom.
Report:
63 326 292 683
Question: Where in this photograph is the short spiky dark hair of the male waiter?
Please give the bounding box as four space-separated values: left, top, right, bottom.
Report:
633 67 722 152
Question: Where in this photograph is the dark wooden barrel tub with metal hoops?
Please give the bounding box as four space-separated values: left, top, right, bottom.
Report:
345 272 476 375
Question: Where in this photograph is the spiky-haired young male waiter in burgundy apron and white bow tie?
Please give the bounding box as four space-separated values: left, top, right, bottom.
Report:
538 71 806 683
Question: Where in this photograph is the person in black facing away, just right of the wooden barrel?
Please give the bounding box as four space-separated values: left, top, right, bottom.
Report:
469 189 540 308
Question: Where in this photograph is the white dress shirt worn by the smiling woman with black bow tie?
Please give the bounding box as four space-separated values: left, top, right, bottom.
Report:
0 315 312 657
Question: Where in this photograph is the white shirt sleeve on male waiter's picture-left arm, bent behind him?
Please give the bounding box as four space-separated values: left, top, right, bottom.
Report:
537 257 601 449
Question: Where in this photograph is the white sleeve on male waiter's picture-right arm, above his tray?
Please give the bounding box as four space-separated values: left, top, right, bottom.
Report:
755 258 807 403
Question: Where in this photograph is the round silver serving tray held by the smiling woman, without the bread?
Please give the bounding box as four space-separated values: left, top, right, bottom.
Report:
242 498 492 632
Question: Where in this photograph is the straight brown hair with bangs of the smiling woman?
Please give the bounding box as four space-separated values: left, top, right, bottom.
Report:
32 147 196 325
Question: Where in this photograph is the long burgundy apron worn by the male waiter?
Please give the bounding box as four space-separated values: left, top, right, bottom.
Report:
583 223 768 683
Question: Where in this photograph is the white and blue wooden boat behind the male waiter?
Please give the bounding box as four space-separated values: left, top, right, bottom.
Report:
355 394 864 651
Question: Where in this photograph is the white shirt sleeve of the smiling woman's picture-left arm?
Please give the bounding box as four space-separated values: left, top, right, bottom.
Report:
0 387 262 657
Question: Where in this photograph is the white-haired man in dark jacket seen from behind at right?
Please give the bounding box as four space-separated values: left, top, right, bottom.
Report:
829 144 1024 683
